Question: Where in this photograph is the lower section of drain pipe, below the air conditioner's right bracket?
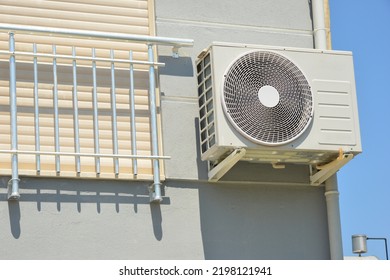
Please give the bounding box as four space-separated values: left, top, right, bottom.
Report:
325 174 344 260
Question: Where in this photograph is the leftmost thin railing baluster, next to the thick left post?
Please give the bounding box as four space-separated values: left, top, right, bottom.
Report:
33 43 41 174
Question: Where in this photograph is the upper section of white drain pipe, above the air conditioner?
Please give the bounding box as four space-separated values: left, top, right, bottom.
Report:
311 0 327 50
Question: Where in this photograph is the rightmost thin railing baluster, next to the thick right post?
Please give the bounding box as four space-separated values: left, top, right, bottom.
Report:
129 51 138 176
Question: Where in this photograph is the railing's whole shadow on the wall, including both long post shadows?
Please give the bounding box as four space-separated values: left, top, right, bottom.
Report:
0 177 171 240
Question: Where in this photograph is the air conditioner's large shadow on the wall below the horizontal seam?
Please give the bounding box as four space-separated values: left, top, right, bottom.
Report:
199 184 330 260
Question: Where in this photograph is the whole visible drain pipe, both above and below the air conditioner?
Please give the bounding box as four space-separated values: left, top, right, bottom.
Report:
311 0 344 260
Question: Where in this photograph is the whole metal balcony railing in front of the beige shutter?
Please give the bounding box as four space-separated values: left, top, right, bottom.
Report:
0 24 193 202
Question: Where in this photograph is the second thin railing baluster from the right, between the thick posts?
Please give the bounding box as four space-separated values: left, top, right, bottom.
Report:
110 49 119 175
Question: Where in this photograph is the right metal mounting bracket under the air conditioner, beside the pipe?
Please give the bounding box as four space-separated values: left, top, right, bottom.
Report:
310 150 353 186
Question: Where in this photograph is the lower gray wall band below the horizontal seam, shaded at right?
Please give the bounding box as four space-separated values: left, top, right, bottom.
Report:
0 178 329 259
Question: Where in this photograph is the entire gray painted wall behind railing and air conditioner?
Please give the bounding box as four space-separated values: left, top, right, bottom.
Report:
0 0 329 259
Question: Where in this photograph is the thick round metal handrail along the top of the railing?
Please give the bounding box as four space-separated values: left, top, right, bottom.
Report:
0 24 194 48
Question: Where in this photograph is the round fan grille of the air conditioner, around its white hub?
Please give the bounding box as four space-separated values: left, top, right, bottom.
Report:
223 51 313 145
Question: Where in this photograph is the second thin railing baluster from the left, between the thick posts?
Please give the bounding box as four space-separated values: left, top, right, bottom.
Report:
53 45 61 174
